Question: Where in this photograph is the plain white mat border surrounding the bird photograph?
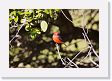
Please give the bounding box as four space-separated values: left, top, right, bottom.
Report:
0 0 109 78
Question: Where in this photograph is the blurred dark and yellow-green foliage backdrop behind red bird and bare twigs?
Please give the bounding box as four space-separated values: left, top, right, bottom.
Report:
9 9 99 68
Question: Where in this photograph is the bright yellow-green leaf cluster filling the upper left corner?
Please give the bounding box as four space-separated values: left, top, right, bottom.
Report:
9 9 60 39
